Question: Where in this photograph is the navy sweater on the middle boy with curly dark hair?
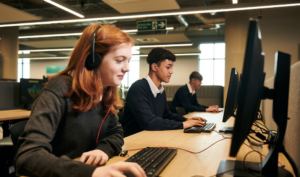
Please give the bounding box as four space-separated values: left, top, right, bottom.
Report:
122 79 186 137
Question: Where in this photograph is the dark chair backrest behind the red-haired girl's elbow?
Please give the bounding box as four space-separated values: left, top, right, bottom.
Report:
9 120 28 153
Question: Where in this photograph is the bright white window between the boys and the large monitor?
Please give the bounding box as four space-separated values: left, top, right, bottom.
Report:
199 43 225 86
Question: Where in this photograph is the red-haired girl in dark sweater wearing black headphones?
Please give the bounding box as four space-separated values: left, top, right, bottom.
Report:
15 24 146 177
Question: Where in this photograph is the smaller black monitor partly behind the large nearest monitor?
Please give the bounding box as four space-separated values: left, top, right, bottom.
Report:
223 68 239 122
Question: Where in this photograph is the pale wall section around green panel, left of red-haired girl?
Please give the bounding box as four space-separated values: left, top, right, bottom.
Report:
30 60 69 79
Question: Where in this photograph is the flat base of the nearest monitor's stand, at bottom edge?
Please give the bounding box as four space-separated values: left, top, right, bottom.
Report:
216 160 293 177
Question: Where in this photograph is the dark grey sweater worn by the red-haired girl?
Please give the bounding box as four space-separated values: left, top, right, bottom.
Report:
15 76 124 177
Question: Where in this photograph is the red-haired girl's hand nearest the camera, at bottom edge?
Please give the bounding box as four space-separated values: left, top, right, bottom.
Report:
92 162 147 177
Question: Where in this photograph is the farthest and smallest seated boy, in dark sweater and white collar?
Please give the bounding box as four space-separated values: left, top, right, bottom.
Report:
170 71 219 113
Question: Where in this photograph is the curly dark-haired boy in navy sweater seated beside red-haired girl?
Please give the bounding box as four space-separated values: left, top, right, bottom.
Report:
121 48 206 137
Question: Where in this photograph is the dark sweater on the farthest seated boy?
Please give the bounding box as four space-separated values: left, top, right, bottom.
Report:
171 84 208 113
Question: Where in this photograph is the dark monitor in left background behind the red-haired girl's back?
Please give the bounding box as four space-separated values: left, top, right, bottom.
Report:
20 79 45 109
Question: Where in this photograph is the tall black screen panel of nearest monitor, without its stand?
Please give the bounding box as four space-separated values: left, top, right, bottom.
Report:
230 21 264 157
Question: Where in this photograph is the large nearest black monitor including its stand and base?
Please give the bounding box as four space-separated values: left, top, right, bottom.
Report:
217 20 292 176
